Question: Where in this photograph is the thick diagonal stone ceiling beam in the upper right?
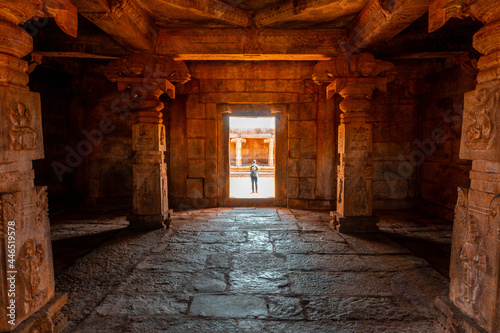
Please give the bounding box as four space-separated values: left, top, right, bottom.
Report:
344 0 432 54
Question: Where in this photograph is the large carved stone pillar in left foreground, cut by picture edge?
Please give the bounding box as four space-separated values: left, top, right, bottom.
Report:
0 1 77 332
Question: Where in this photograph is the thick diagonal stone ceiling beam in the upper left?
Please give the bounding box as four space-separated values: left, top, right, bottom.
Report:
72 0 158 53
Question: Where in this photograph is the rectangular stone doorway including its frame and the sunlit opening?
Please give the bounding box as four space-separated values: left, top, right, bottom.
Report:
217 104 288 207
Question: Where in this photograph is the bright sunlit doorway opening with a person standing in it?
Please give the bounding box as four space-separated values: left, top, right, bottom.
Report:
229 117 276 199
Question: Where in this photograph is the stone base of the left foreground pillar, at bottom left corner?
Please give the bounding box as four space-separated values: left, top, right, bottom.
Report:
12 294 68 333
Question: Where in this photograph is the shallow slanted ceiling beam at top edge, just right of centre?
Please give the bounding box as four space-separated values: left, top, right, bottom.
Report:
254 0 366 27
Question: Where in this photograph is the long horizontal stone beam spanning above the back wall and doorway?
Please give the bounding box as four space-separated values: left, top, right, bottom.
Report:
156 29 344 61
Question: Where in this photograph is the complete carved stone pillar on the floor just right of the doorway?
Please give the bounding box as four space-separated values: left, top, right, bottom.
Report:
313 53 394 233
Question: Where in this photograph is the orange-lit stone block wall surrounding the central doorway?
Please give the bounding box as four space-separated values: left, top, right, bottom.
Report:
168 62 337 209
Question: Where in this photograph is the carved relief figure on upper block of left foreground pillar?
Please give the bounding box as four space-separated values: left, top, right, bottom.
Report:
10 102 38 150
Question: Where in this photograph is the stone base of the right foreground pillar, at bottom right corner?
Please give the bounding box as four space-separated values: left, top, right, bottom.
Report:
435 297 487 333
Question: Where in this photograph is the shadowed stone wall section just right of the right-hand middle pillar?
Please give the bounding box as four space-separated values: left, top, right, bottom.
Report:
370 81 418 209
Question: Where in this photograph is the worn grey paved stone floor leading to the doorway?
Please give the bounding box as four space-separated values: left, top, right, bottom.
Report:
57 208 448 333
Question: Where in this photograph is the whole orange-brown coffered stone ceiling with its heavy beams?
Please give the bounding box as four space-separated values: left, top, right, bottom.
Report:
32 0 480 61
